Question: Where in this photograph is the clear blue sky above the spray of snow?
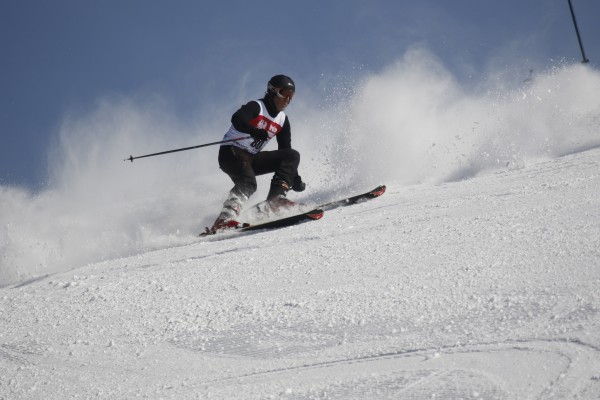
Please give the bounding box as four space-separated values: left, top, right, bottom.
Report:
0 0 600 189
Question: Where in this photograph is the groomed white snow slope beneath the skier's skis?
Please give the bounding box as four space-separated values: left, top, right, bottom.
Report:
0 149 600 400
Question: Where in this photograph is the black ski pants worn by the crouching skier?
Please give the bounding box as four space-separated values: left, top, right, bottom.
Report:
219 146 300 197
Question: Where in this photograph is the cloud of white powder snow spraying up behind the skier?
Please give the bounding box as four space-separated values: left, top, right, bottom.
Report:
0 54 600 287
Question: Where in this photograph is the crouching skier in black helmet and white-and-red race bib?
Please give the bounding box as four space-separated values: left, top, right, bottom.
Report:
207 75 306 233
